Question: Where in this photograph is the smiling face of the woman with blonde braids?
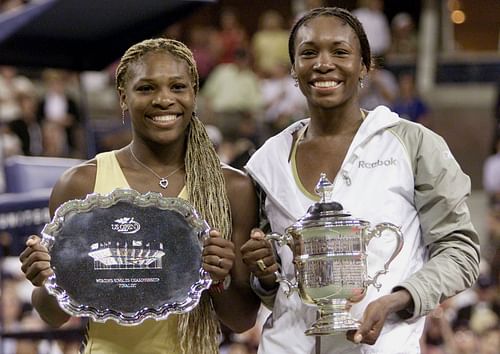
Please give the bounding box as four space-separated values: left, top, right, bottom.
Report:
120 52 195 144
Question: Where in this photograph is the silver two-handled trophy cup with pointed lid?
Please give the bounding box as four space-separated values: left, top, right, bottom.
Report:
266 173 403 336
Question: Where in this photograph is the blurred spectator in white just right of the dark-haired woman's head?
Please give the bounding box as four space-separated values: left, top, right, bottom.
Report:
352 0 391 57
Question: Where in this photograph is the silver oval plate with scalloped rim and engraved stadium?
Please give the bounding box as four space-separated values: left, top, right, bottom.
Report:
42 189 212 325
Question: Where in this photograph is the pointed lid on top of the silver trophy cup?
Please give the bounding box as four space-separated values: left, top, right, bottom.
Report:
296 173 364 227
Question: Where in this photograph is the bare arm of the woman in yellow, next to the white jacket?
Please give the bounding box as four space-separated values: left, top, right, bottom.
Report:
207 169 260 332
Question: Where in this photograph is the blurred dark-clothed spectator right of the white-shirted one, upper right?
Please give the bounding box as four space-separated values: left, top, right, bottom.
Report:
390 12 418 55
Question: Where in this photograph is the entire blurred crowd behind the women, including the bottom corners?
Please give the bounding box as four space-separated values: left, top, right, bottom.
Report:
0 0 500 354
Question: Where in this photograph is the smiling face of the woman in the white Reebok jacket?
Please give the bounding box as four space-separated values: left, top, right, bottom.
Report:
293 16 367 109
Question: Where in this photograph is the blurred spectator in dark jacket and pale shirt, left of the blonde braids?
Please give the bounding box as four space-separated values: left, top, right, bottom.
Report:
37 69 80 157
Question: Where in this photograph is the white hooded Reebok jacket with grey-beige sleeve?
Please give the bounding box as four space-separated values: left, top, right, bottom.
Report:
246 106 479 354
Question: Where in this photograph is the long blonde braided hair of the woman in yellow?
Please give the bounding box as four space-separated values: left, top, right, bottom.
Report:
116 38 231 354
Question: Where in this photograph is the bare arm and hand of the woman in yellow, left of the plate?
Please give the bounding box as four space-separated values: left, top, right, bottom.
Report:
20 163 95 327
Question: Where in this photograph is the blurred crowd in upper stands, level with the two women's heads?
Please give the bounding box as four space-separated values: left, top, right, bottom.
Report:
0 0 430 177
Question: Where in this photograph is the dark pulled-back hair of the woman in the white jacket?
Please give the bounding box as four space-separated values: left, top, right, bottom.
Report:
288 7 372 70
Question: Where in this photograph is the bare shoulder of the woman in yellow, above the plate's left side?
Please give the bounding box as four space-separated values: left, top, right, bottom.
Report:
49 160 97 212
